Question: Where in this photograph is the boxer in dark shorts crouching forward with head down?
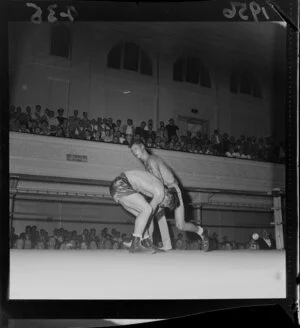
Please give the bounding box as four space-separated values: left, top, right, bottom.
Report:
109 170 179 253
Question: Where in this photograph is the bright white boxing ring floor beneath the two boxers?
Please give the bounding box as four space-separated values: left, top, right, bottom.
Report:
9 250 286 300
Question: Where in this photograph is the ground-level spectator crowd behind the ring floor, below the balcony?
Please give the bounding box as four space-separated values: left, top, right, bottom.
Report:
10 225 275 250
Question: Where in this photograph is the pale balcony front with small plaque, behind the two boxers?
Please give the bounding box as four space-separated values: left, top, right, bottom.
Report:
9 132 285 208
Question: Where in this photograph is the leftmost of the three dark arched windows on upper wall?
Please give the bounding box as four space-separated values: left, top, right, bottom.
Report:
107 41 153 76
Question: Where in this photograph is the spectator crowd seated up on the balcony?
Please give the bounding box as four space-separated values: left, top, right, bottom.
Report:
9 105 285 163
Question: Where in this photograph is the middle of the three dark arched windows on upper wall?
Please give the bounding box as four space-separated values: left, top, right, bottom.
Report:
173 56 211 88
